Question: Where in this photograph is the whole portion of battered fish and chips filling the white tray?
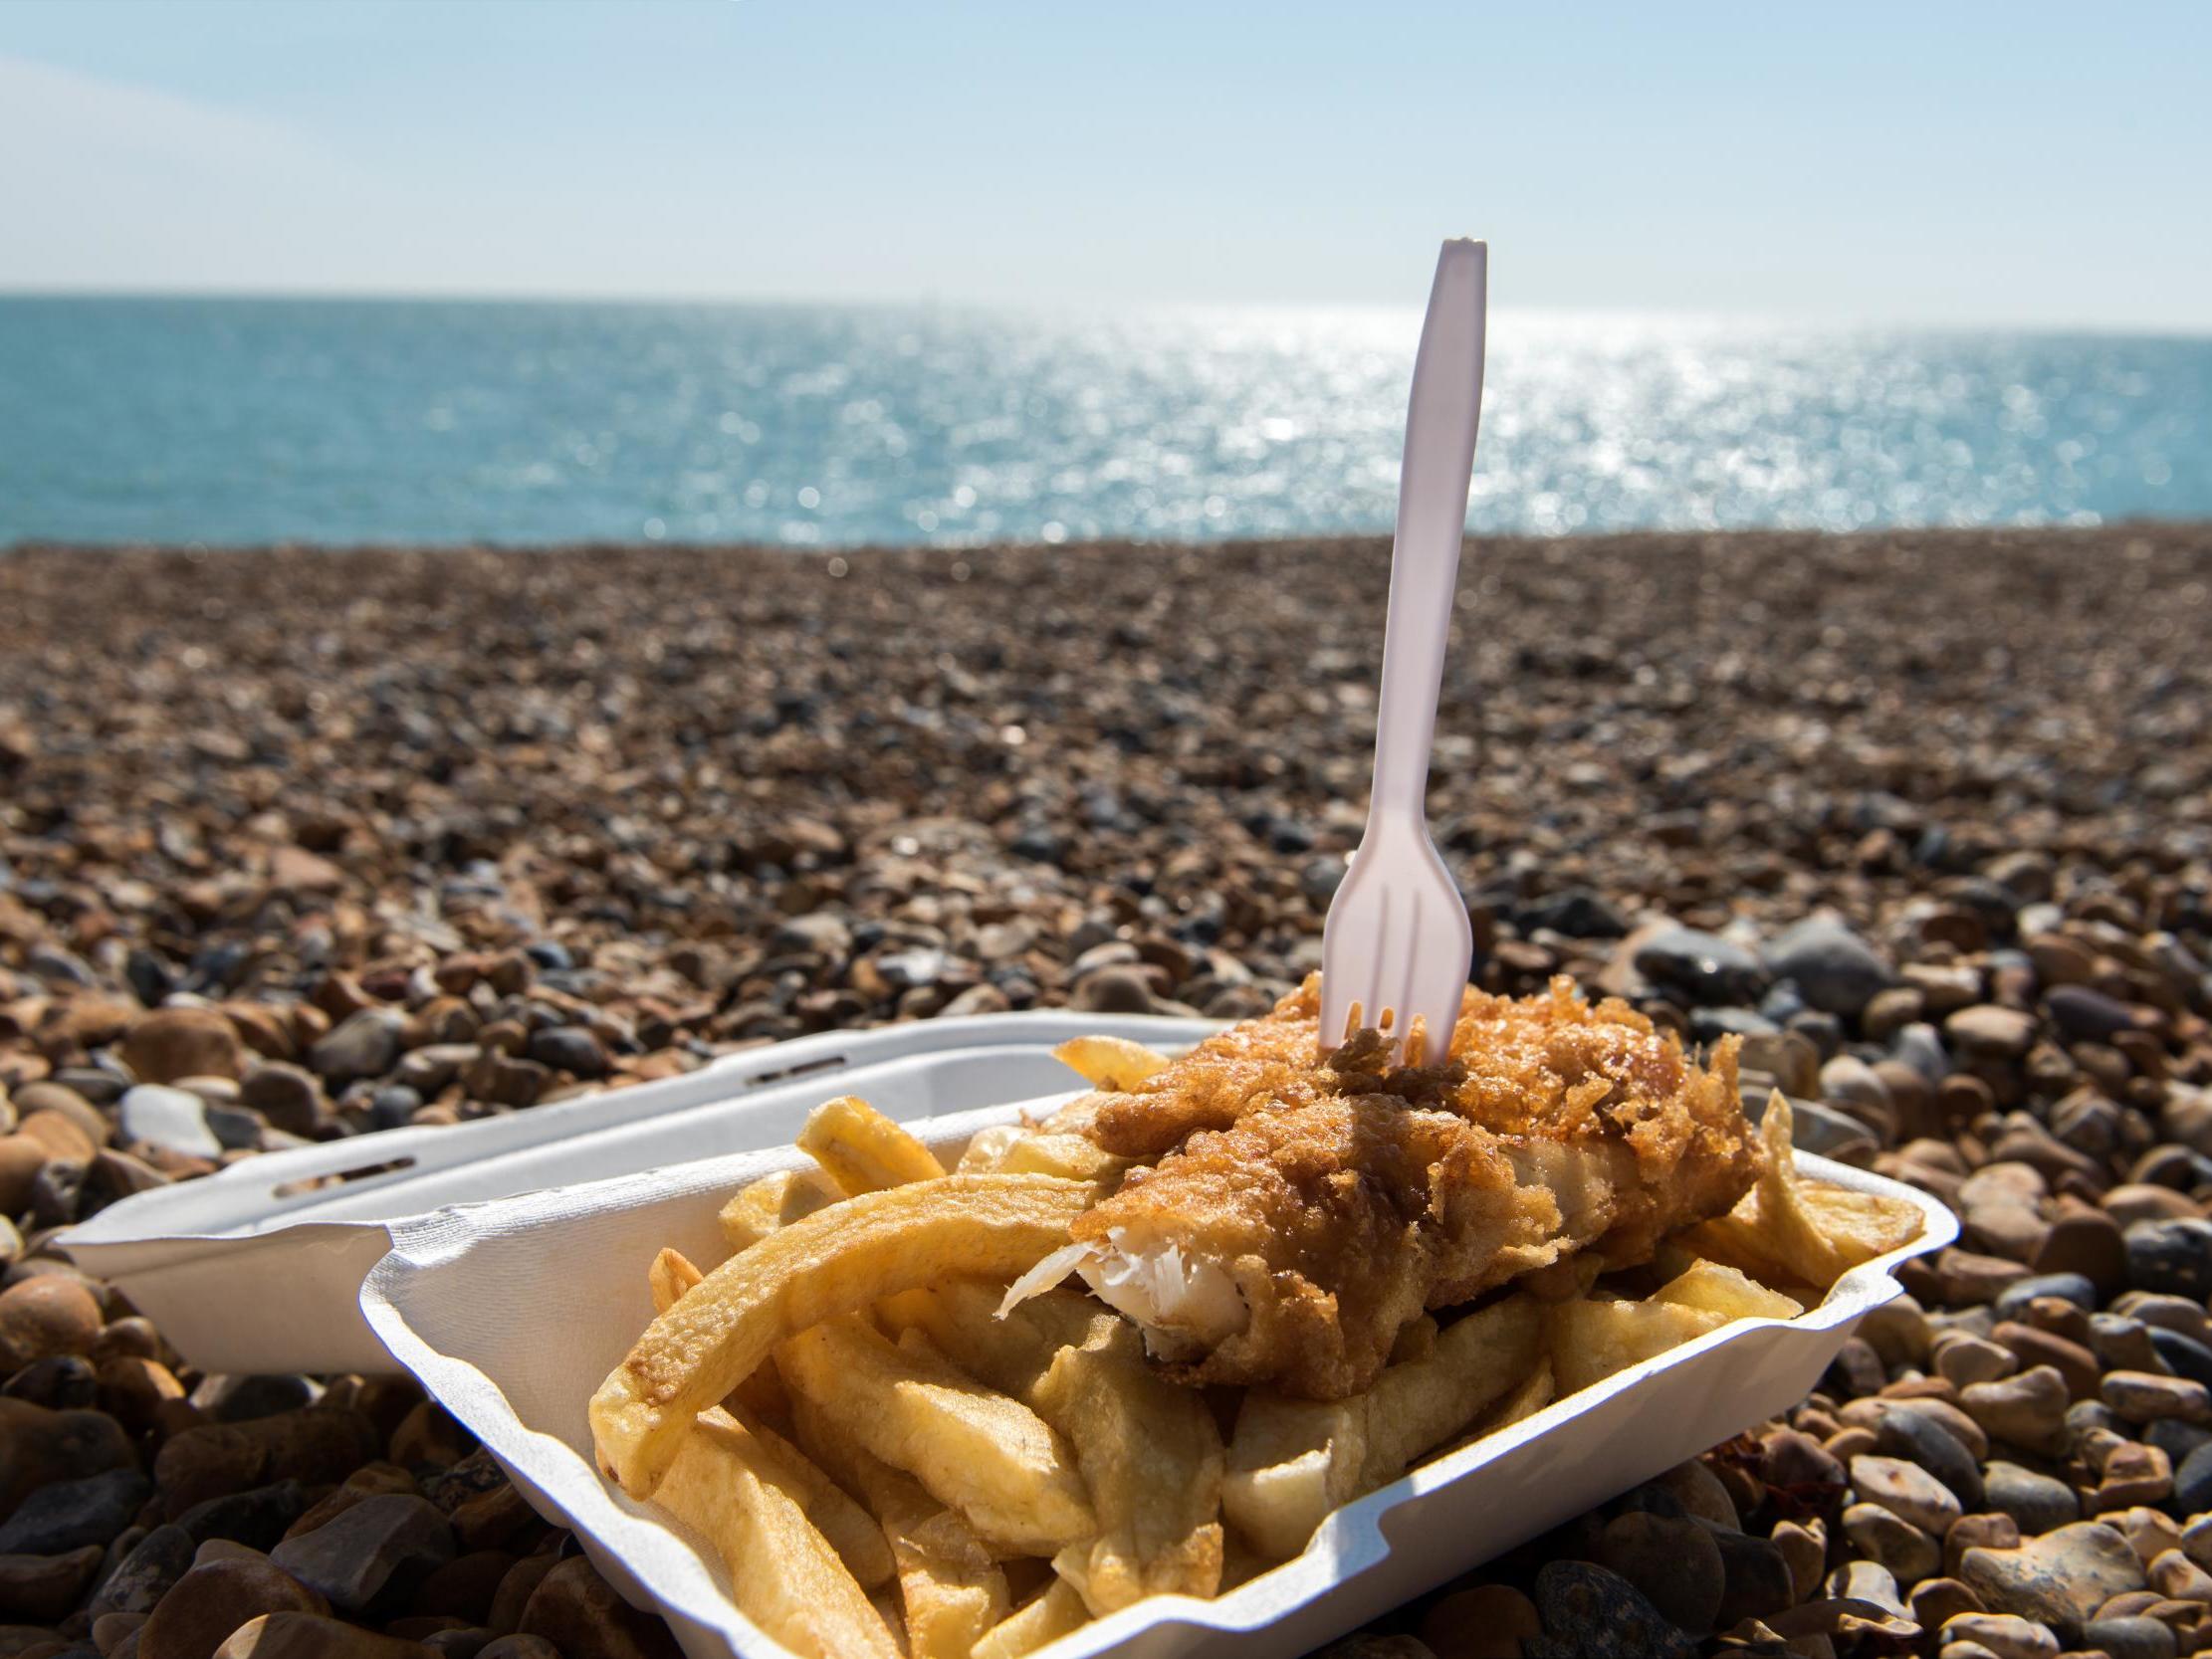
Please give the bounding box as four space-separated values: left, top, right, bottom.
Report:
590 980 1922 1659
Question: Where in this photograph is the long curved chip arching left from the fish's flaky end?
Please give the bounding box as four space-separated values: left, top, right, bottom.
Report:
590 1174 1095 1504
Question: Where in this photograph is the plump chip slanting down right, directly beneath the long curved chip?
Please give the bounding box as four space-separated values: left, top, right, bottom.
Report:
776 1319 1097 1555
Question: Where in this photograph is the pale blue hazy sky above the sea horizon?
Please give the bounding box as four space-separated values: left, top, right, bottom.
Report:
0 0 2212 331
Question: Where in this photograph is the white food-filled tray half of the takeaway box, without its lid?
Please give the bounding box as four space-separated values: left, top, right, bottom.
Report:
360 1091 1957 1659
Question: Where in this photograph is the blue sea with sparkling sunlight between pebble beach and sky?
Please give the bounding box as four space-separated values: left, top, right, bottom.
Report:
0 299 2212 546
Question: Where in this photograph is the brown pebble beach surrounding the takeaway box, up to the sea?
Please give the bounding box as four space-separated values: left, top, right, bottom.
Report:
0 524 2212 1659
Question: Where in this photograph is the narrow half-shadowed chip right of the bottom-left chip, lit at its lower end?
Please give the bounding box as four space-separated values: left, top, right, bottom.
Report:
794 1396 1008 1659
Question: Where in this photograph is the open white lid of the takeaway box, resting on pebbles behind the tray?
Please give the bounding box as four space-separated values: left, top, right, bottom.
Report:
60 1009 1218 1373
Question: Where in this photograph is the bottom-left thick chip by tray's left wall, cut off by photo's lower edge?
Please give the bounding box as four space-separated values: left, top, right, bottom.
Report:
655 1411 898 1659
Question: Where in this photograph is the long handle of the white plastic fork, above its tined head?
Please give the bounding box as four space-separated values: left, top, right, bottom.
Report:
1367 239 1488 825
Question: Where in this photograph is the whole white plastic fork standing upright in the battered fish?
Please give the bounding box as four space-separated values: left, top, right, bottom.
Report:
1321 241 1488 1064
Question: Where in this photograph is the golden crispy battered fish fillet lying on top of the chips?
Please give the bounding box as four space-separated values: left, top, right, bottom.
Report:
1017 975 1756 1400
